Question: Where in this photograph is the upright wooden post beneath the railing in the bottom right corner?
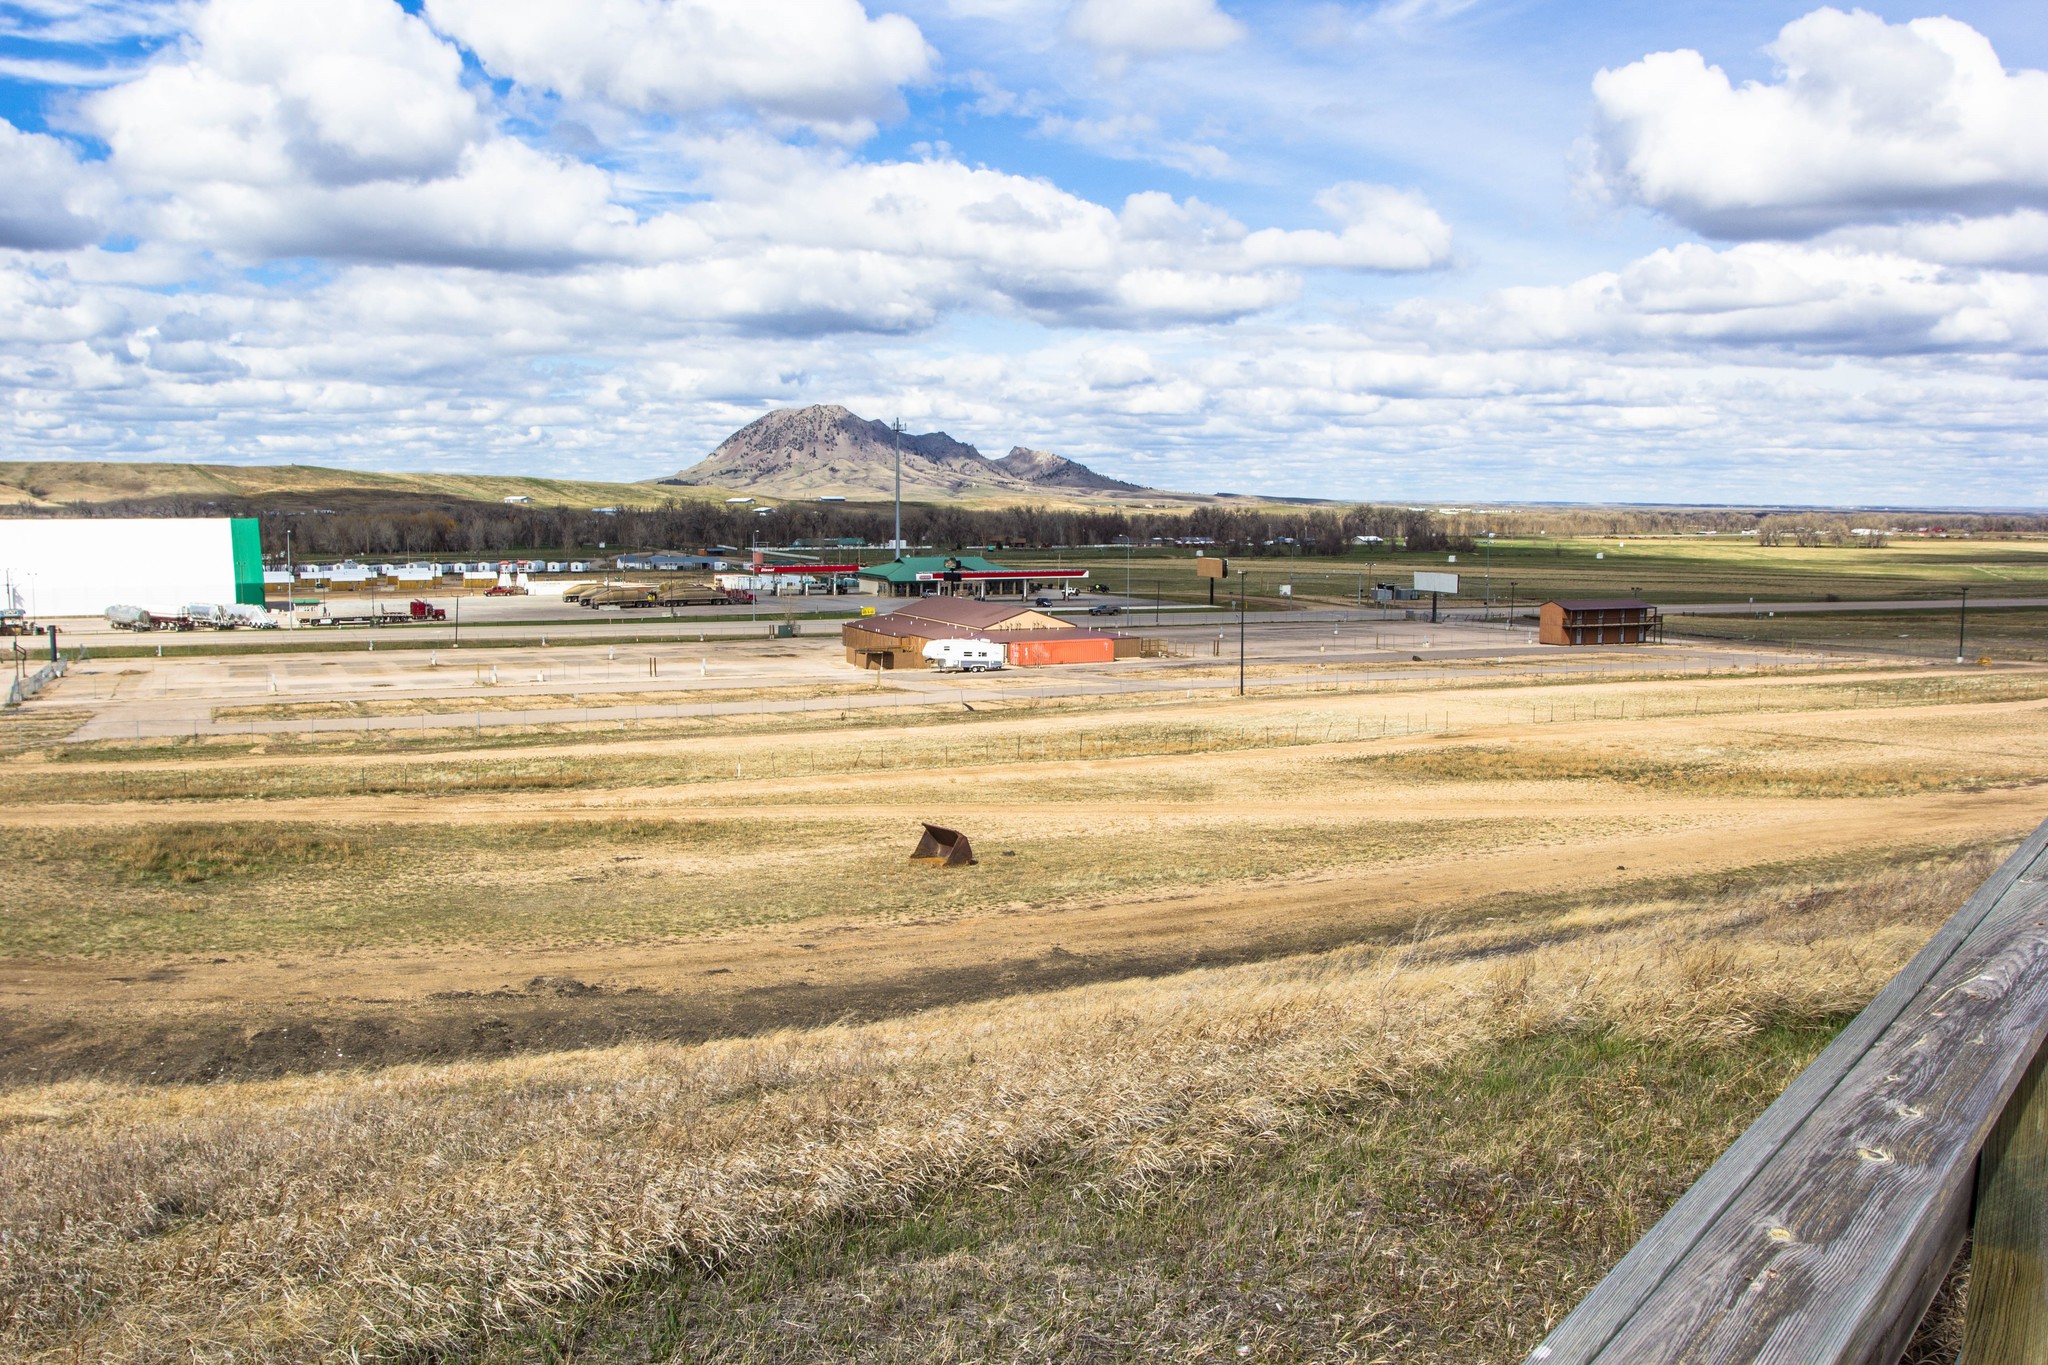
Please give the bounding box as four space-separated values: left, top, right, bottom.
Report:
1958 1054 2048 1365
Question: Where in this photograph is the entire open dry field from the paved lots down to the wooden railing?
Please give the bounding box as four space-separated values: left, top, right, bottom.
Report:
0 634 2048 1363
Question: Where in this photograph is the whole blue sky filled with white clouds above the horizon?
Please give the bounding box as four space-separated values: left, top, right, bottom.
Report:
0 0 2048 505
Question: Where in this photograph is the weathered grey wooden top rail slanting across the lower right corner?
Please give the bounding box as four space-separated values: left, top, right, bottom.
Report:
1528 825 2048 1365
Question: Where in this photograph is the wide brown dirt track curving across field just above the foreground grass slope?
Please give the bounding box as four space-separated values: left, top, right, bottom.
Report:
12 788 2048 1083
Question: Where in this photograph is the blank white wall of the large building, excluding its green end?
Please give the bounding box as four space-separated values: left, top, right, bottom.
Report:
0 516 236 618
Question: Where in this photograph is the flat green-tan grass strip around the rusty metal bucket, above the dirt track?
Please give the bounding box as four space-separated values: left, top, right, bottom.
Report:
0 810 1507 958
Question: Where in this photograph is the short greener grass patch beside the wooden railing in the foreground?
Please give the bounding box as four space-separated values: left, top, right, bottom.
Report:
512 1015 1847 1365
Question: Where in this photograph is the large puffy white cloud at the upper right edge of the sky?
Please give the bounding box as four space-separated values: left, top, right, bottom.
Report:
1593 8 2048 237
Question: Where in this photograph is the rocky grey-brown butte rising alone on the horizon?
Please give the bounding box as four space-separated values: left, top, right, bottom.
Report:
662 405 1153 501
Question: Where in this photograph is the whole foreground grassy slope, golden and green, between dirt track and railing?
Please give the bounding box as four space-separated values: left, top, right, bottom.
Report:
0 855 1991 1363
